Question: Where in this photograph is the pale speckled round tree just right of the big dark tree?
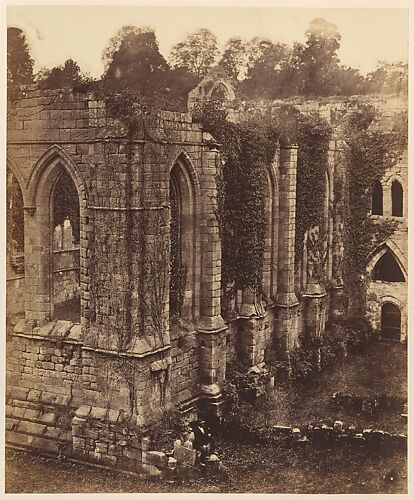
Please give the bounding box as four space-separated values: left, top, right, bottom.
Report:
170 28 218 79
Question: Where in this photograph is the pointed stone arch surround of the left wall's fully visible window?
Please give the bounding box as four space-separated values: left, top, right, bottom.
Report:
25 146 88 324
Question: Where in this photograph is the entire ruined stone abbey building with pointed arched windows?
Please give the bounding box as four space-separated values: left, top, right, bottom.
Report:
6 82 407 468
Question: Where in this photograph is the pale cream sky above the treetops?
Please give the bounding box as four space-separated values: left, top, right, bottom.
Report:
7 5 408 77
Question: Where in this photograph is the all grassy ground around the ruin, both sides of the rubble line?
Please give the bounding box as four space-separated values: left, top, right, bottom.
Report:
6 342 407 494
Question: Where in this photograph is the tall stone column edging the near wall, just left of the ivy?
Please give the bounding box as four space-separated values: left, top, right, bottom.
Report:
198 139 227 411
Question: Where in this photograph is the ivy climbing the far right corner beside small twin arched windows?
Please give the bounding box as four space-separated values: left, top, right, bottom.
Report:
344 105 407 316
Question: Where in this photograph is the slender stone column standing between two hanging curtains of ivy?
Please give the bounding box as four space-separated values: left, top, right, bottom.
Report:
275 146 299 357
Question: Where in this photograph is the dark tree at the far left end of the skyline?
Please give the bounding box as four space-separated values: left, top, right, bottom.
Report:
7 27 34 91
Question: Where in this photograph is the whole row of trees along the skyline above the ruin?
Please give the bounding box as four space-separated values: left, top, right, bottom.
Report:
7 18 408 103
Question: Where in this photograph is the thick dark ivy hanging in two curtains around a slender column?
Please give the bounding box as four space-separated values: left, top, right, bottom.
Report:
194 101 332 308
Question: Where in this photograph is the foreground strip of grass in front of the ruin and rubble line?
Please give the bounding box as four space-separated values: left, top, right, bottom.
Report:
6 442 407 494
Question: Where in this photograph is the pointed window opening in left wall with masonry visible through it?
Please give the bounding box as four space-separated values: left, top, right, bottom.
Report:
50 169 80 322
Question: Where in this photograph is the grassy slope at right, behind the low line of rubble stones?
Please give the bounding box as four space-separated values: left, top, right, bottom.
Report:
270 342 407 432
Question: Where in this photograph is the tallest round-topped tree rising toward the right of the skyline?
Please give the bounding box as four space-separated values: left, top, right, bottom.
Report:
301 18 341 95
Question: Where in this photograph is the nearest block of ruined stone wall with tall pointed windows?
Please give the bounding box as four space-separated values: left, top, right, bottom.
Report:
8 87 226 458
